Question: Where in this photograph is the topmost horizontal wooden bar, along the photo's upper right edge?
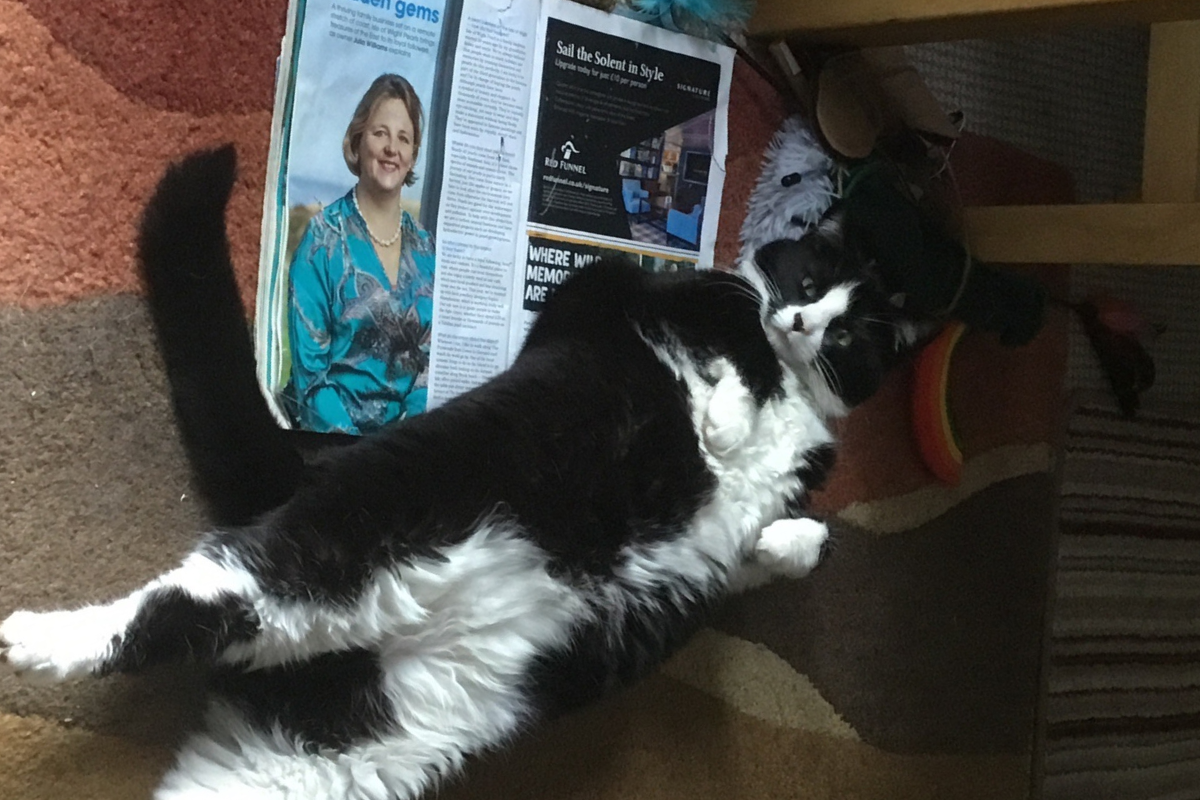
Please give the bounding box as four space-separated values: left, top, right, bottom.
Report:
749 0 1200 46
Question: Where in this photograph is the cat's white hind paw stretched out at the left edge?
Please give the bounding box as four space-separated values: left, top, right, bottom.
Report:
0 606 120 684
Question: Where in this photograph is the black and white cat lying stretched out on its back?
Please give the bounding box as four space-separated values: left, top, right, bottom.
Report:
0 149 901 800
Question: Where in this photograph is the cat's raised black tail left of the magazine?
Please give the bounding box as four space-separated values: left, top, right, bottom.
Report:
138 145 304 525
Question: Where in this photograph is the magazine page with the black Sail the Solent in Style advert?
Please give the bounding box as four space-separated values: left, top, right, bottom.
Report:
510 0 734 342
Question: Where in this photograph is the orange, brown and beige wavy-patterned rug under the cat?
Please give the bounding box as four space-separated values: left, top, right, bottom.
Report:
0 0 1072 800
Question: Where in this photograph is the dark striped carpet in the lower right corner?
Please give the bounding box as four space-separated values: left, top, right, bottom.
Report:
1043 405 1200 800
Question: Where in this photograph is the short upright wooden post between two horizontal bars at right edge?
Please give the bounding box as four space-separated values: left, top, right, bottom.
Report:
1141 22 1200 203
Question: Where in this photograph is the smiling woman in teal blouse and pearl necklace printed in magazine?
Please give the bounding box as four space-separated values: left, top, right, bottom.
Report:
284 73 434 433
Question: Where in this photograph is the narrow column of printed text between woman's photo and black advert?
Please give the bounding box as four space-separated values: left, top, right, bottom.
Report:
428 0 540 407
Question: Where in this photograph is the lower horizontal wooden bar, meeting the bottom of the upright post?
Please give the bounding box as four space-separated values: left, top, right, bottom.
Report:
965 203 1200 265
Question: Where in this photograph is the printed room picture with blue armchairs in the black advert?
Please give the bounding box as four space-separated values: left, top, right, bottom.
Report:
617 112 715 251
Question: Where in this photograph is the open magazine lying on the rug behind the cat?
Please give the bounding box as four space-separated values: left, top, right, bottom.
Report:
256 0 733 433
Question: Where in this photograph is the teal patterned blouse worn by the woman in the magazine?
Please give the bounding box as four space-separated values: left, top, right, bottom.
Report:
286 193 434 433
